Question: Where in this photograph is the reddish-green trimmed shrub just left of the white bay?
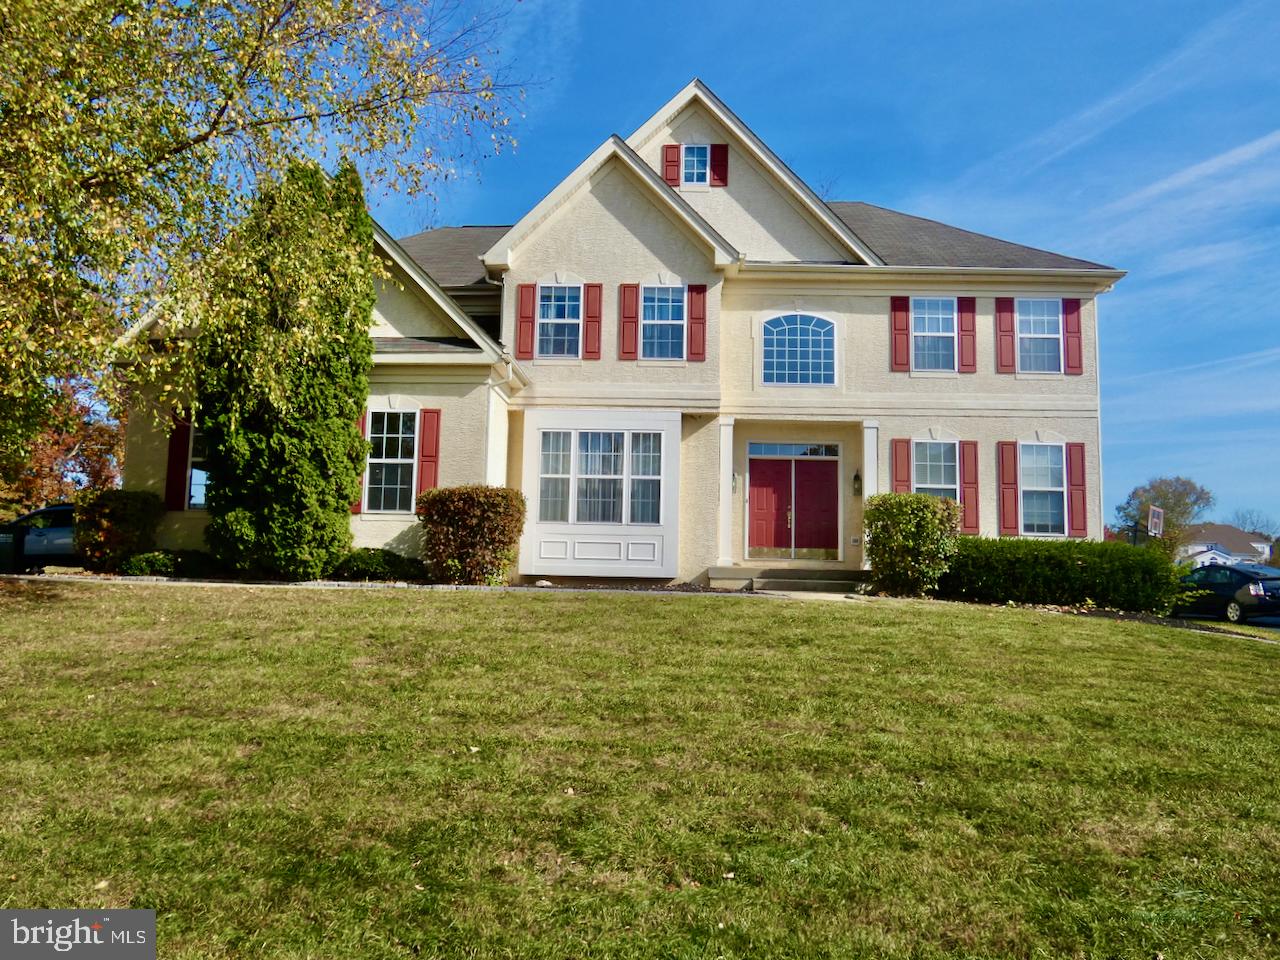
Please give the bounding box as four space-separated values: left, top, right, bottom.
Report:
417 485 525 584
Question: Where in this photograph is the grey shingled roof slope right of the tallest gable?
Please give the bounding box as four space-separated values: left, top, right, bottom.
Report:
827 200 1114 270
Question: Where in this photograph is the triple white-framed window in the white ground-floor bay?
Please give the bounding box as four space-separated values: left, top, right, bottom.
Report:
538 430 663 525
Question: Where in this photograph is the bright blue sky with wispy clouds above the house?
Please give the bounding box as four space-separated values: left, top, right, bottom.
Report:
375 0 1280 520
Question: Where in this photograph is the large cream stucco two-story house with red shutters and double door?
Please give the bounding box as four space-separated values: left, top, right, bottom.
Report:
125 81 1123 580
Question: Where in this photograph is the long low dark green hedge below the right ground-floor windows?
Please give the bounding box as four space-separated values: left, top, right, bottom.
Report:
938 536 1181 613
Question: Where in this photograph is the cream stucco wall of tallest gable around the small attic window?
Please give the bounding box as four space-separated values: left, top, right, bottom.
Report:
632 102 850 262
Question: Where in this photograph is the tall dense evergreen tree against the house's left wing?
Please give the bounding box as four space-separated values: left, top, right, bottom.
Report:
196 161 378 580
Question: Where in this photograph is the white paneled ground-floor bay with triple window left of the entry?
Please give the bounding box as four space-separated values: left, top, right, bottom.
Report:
520 410 680 577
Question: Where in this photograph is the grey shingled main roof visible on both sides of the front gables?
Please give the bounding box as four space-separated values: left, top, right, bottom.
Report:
399 200 1111 277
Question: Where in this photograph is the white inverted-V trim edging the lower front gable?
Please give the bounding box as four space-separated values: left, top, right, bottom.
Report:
483 133 741 268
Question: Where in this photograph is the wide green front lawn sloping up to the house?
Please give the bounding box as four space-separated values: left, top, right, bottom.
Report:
0 582 1280 960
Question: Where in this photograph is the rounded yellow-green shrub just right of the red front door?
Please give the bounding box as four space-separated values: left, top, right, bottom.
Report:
863 493 960 596
